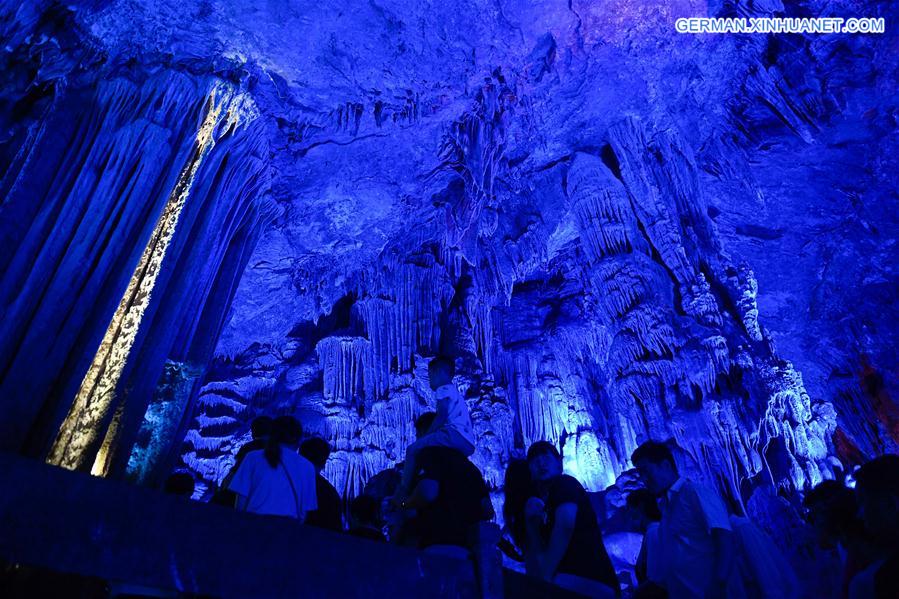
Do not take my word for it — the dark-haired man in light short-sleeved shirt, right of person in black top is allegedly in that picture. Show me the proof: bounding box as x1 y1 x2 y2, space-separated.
631 441 744 599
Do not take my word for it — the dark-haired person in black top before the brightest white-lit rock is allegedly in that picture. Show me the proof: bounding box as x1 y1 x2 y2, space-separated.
524 441 619 597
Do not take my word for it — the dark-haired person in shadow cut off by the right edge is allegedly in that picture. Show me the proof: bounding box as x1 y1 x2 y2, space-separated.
849 454 899 599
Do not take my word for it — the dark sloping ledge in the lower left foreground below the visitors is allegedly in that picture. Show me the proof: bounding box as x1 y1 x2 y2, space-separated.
0 454 572 599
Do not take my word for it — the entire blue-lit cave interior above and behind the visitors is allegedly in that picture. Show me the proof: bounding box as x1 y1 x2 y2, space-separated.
0 0 899 596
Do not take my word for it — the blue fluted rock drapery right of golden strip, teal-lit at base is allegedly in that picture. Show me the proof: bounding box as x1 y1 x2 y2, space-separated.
98 86 277 482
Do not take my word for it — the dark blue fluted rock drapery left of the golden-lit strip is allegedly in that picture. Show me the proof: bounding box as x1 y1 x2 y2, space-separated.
0 75 204 453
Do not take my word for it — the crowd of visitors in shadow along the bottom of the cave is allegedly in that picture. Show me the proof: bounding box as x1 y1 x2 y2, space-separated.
166 358 899 599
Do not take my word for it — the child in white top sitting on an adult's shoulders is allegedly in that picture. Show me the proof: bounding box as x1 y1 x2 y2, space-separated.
398 356 475 501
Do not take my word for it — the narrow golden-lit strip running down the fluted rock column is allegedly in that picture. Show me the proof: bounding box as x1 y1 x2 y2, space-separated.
47 87 247 475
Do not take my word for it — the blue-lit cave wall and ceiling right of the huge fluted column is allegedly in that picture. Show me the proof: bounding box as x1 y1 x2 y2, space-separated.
165 3 897 509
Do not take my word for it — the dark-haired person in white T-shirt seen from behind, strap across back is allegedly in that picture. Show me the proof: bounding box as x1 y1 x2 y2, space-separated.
229 416 318 521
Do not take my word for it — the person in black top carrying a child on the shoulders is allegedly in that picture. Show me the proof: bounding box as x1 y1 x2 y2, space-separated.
401 415 494 549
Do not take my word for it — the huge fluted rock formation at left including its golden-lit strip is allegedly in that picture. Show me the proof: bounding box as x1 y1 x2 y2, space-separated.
0 0 274 473
